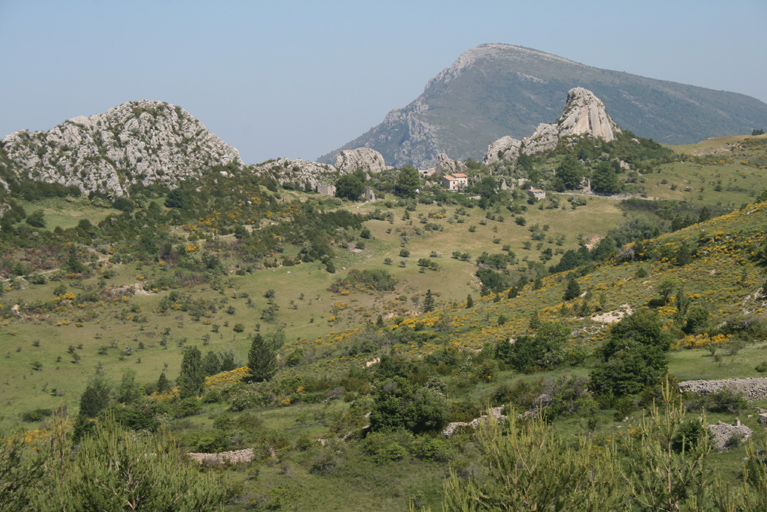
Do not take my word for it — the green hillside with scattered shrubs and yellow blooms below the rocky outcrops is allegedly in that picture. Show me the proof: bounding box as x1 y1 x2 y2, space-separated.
0 132 767 510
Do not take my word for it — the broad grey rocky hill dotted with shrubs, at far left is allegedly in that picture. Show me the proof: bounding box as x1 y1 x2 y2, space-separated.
2 100 242 196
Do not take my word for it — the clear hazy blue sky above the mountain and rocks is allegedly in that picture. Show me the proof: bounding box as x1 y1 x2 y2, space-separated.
0 0 767 163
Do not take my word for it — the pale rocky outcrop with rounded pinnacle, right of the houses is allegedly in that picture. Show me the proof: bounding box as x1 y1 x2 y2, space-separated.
484 87 621 164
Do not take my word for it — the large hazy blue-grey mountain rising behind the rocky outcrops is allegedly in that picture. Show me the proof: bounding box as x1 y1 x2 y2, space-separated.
319 44 767 168
